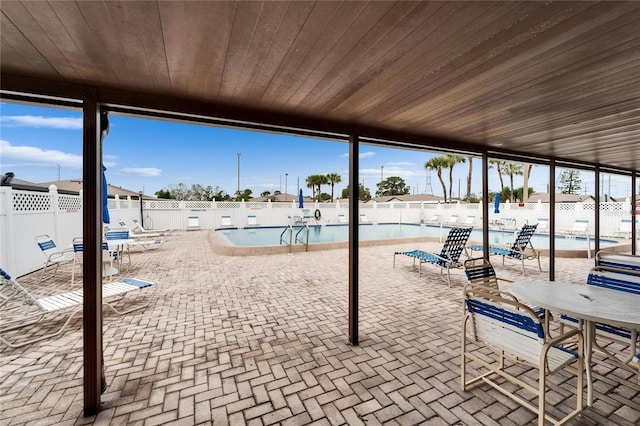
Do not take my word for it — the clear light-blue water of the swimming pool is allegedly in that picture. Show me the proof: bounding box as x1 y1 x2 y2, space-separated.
216 223 617 250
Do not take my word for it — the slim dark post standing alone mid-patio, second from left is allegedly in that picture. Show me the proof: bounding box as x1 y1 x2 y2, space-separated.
349 135 360 345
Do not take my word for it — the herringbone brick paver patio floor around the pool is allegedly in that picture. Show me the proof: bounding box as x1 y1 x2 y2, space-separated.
0 231 640 425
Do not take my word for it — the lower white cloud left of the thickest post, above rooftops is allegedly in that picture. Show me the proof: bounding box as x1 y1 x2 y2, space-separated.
0 140 82 169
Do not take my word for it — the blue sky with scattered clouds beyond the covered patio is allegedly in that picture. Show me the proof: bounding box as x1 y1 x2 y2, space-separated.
0 103 630 197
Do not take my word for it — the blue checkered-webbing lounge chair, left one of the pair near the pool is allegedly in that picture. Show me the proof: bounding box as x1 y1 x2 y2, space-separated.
393 227 473 287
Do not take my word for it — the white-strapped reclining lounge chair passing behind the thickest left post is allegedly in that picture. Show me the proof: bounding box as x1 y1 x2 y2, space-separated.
0 268 158 348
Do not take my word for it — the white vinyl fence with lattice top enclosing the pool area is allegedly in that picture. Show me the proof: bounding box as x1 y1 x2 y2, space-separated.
0 186 631 277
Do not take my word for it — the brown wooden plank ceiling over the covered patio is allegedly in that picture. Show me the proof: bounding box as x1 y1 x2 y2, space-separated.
0 0 640 170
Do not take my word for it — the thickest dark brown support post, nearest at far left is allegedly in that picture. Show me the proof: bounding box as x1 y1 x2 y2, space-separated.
82 88 102 416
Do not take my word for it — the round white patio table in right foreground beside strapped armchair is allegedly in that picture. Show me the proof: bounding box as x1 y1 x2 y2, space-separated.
509 281 640 406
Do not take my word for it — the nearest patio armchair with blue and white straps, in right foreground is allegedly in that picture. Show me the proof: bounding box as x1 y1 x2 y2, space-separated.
460 287 584 426
